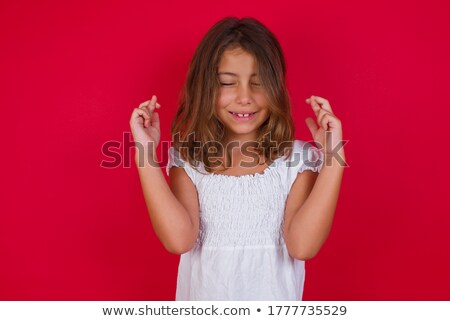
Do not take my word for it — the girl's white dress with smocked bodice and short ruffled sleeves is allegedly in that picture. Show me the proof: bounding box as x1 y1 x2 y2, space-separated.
166 140 323 301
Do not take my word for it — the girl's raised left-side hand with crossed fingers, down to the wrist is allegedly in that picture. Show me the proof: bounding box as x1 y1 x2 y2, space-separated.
130 95 161 154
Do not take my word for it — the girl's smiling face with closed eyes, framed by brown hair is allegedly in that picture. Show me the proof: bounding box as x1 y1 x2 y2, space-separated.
216 48 270 142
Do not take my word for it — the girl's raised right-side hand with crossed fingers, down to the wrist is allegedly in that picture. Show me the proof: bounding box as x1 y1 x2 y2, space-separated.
305 96 342 154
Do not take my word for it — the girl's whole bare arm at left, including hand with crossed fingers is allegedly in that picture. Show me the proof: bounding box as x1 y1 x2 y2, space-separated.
130 95 199 254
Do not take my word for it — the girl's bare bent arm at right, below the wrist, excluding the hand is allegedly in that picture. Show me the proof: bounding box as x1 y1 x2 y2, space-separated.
284 149 345 260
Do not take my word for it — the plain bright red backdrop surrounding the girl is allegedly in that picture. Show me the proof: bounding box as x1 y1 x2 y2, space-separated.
0 0 450 300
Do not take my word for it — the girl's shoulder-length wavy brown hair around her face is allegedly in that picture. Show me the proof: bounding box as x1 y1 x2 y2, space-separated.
171 17 295 173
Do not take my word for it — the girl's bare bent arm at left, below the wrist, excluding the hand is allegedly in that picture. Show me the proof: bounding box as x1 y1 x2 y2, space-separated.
135 153 199 254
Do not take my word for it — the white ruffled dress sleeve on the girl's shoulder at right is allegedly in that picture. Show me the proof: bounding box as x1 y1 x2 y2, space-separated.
286 140 324 189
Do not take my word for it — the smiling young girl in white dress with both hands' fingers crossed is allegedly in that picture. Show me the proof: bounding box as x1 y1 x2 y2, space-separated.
130 17 345 300
